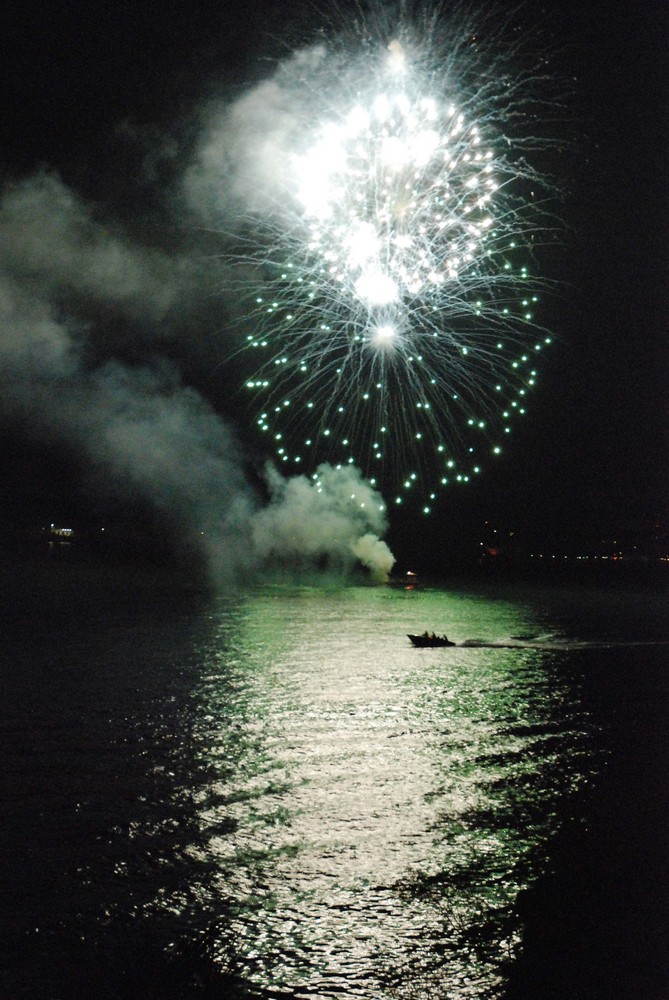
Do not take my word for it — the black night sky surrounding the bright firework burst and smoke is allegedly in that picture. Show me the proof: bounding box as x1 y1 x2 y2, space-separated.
0 0 669 572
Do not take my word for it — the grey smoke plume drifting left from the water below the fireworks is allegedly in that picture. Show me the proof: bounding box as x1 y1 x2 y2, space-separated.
0 157 393 584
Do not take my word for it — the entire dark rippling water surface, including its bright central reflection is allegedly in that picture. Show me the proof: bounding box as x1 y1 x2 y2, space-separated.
0 567 669 1000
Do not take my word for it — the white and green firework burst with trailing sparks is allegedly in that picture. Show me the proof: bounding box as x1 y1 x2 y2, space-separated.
213 3 550 513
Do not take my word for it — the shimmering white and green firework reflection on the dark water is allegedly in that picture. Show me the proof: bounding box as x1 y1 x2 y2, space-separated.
174 588 594 1000
